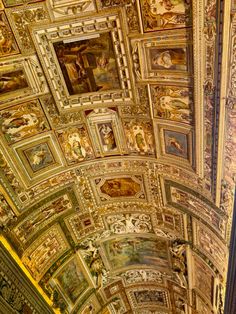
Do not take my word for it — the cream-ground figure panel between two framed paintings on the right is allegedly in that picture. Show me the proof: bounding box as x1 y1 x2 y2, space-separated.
151 85 192 124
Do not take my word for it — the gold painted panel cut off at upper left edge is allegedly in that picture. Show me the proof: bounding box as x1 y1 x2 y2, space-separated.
0 12 19 57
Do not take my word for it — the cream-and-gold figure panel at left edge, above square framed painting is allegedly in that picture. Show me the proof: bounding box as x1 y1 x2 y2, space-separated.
0 101 50 143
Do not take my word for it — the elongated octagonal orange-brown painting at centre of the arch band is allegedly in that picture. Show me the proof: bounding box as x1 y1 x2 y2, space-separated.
100 178 141 197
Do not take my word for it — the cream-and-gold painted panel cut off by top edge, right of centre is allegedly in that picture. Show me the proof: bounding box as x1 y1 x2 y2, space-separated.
141 0 191 32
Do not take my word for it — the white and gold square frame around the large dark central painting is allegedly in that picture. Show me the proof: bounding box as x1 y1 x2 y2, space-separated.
32 15 133 109
